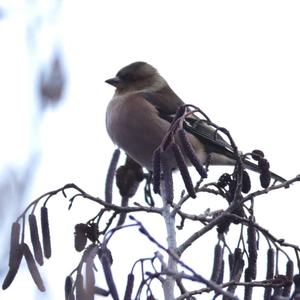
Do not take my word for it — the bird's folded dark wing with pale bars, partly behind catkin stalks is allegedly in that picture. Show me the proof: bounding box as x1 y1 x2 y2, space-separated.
142 88 233 158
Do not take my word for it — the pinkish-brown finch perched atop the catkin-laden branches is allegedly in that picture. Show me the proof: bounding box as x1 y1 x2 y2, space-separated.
105 61 285 182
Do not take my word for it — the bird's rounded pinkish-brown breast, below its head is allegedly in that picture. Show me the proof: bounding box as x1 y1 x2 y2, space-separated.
106 95 169 169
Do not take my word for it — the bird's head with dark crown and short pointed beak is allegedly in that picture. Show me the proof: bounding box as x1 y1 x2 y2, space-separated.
105 61 167 93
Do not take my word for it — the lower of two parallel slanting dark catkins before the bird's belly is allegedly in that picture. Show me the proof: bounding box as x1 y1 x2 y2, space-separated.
171 143 196 198
